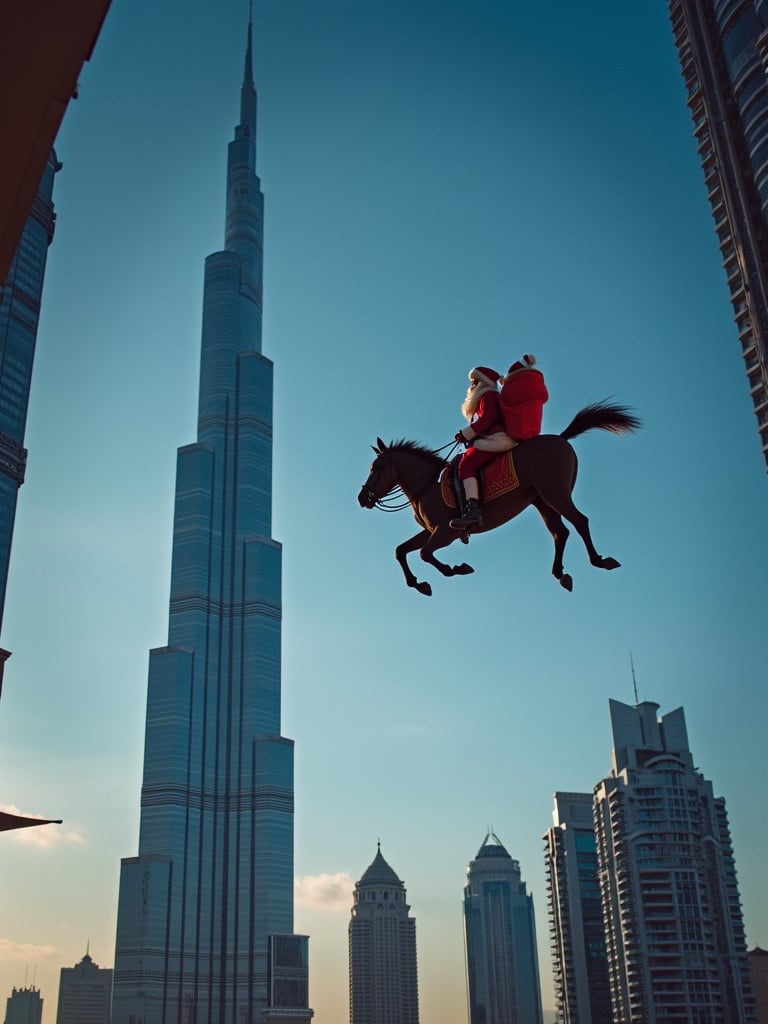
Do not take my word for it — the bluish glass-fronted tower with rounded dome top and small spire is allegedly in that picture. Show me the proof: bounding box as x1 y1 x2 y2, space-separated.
464 831 542 1024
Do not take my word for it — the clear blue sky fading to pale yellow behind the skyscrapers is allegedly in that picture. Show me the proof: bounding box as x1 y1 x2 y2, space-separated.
0 0 768 1024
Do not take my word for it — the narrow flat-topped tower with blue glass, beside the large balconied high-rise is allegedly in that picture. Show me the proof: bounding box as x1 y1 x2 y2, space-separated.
544 793 613 1024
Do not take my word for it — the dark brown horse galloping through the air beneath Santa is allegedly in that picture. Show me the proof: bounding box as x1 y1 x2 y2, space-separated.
357 401 640 596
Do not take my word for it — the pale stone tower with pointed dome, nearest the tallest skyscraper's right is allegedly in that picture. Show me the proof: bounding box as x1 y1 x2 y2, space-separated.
349 845 419 1024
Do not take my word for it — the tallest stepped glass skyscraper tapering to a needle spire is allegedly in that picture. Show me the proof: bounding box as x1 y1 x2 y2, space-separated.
113 14 312 1024
